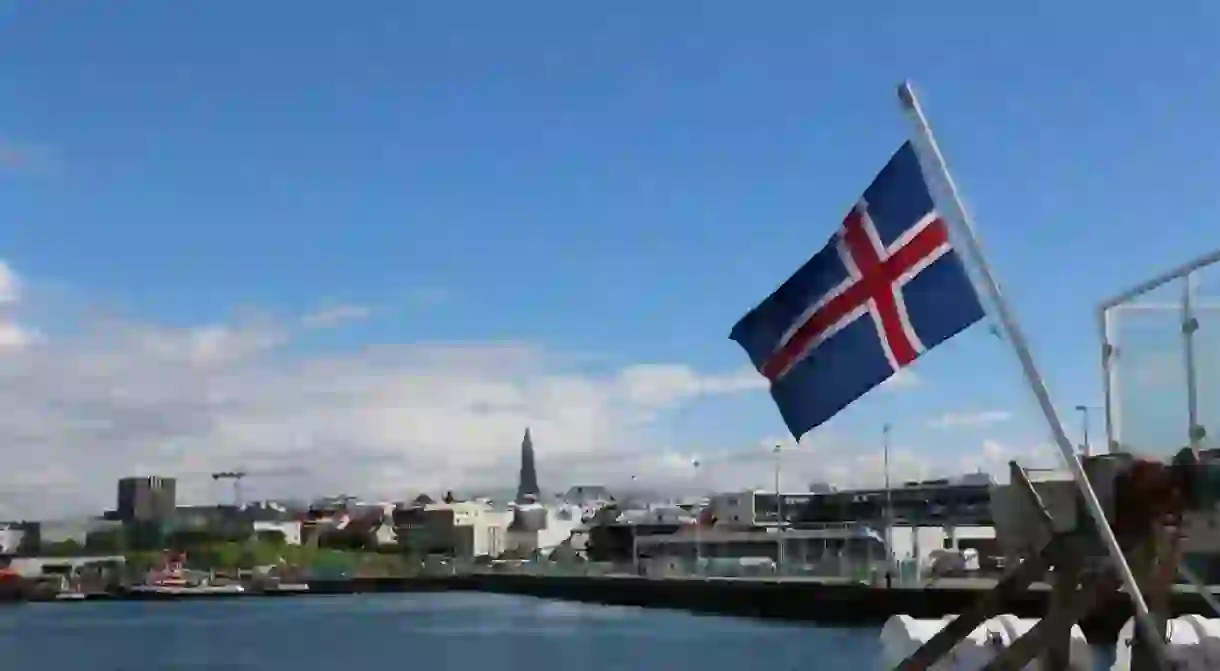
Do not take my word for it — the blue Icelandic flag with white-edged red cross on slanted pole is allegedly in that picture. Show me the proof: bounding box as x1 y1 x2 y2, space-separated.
730 143 985 439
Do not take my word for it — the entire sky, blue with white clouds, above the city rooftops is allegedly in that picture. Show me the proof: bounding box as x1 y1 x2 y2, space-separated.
0 0 1220 517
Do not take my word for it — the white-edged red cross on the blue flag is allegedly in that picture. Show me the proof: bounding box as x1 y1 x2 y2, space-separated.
763 204 949 381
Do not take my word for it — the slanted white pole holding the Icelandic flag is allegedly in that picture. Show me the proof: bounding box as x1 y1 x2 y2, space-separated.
898 82 1166 659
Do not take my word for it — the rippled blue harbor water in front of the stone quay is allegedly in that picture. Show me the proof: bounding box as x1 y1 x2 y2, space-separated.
0 593 878 671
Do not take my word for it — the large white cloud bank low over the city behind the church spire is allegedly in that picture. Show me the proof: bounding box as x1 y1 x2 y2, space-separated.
0 259 759 517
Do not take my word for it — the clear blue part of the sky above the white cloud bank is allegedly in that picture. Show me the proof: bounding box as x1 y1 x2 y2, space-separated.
0 0 1220 509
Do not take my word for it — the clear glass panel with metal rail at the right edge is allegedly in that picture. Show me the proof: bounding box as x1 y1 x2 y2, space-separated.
1086 251 1220 459
